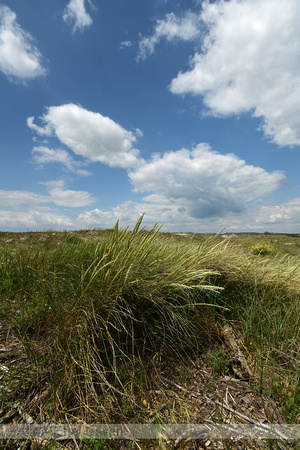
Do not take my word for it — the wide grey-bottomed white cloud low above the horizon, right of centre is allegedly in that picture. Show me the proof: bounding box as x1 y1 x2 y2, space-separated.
129 144 285 219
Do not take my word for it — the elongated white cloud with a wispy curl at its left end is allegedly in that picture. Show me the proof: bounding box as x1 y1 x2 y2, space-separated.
27 103 142 169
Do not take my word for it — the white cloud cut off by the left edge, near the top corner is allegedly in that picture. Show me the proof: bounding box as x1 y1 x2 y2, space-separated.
0 5 46 82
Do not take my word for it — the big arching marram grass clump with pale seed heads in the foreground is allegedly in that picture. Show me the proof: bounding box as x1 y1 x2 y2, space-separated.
0 217 224 422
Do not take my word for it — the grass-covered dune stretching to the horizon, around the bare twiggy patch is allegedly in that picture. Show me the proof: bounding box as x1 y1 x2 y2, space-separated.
0 217 300 448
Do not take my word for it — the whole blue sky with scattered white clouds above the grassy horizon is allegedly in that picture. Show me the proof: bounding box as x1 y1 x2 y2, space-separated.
0 0 300 233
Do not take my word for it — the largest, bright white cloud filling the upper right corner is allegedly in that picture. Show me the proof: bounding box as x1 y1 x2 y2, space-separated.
170 0 300 146
